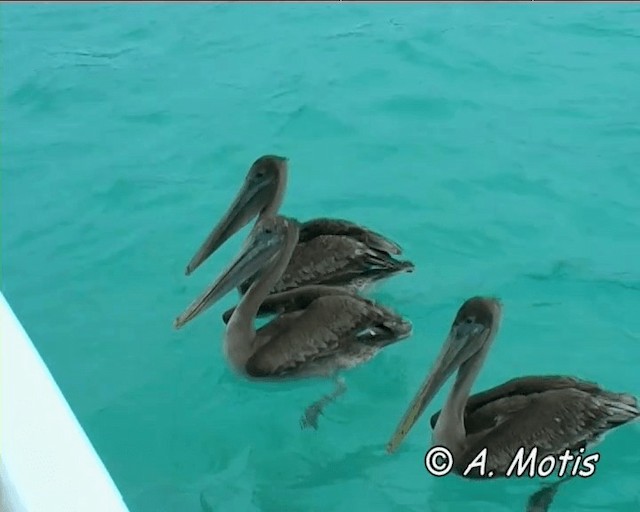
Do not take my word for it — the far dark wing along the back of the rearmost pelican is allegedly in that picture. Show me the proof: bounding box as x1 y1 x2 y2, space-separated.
299 218 402 255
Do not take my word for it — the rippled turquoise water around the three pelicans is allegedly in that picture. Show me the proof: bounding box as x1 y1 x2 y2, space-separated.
1 4 640 512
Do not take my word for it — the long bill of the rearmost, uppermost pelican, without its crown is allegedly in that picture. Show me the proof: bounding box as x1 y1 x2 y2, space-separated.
185 174 274 275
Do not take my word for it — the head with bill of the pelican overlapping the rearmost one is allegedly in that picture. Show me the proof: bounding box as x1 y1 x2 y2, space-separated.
174 216 300 329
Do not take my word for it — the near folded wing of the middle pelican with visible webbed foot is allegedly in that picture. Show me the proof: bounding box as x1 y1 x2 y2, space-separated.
246 294 402 377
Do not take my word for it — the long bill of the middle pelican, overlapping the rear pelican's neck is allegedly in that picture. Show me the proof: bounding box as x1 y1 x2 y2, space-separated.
178 228 281 329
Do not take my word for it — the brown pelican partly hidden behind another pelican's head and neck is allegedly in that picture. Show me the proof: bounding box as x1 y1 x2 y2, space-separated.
185 155 414 294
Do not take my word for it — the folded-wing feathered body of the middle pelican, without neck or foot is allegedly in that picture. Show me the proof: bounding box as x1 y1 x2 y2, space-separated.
245 287 411 378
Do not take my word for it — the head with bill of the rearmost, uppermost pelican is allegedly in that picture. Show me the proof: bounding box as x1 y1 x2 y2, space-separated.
185 155 288 275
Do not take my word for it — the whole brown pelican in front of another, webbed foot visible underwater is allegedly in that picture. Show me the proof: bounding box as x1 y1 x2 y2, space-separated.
174 216 411 428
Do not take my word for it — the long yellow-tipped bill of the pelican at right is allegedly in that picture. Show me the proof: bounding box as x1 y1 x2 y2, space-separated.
387 322 489 453
